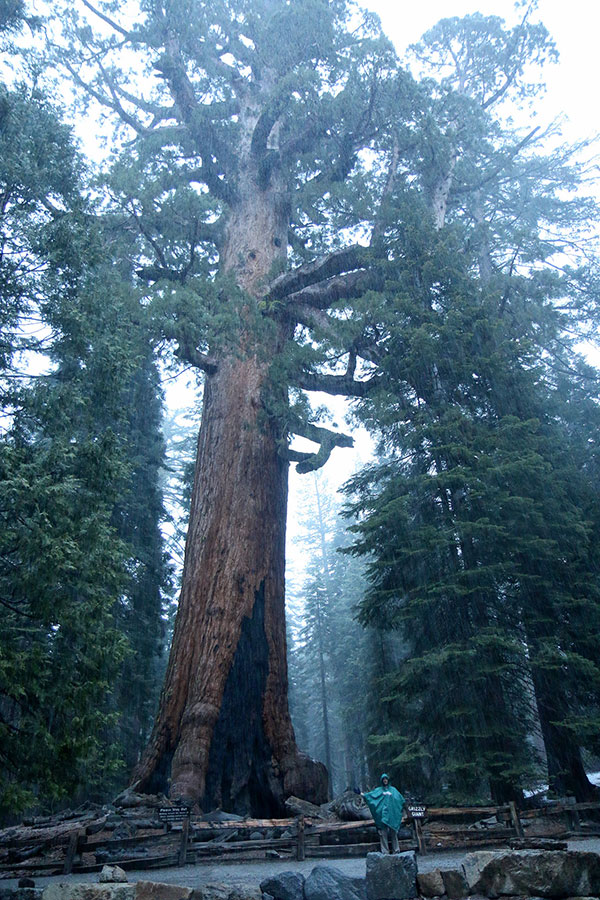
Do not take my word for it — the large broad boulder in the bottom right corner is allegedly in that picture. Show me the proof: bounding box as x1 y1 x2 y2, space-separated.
463 850 600 897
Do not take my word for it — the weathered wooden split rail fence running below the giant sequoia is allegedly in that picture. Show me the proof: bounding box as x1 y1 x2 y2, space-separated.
0 802 600 877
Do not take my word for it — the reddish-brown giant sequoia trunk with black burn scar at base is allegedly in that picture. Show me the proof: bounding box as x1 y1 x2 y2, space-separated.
133 142 327 816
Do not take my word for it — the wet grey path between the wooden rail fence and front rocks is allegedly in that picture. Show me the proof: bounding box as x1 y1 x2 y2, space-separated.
1 838 600 889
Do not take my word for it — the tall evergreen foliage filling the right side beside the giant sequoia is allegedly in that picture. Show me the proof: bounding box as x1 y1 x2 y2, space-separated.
342 16 600 801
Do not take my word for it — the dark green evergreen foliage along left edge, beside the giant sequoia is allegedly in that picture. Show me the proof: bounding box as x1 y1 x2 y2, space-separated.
0 17 167 815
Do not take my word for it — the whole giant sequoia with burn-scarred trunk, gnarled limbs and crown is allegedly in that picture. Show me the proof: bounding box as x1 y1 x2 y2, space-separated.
52 0 410 813
